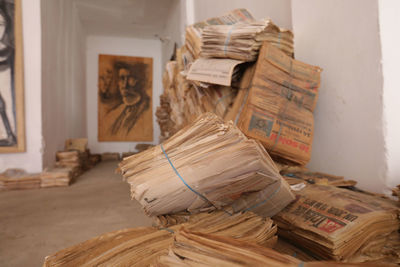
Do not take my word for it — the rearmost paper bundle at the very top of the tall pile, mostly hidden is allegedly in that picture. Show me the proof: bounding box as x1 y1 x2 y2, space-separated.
185 8 254 58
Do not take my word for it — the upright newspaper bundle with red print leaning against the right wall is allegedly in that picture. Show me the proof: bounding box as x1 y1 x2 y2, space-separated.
238 42 321 165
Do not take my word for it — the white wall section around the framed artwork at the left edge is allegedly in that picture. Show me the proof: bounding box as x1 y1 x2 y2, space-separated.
0 0 43 172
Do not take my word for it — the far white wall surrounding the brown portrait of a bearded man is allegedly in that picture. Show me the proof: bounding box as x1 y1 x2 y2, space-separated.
86 36 162 153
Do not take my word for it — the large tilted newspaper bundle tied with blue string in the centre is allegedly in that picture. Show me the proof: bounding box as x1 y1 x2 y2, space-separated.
119 113 293 219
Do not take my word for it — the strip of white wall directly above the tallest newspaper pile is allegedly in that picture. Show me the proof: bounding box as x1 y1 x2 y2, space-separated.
190 0 292 29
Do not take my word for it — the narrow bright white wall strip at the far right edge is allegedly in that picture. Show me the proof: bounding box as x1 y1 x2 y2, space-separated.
379 0 400 191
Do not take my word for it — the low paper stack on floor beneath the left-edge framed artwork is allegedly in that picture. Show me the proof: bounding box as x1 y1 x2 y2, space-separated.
0 169 40 190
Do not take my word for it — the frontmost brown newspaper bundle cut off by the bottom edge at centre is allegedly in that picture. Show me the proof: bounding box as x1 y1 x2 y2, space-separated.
152 228 378 267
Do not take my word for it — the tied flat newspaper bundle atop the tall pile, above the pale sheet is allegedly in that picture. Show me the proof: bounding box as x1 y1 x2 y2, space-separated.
201 19 294 62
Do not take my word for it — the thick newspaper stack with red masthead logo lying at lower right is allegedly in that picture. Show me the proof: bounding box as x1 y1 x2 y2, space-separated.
273 185 400 263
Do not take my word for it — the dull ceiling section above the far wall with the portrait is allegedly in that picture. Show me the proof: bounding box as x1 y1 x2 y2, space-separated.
74 0 174 38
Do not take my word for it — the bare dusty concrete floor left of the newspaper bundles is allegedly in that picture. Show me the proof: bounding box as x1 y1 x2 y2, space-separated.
0 161 152 267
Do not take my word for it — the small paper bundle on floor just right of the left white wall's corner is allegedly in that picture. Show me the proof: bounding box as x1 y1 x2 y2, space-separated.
40 168 73 187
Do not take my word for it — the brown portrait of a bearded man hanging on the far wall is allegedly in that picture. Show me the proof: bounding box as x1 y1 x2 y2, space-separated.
98 55 153 141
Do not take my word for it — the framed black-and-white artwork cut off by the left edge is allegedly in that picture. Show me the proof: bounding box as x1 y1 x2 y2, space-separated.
0 0 25 153
